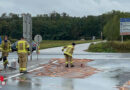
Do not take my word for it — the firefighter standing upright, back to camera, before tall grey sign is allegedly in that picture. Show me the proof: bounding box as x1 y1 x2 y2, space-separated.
16 38 29 73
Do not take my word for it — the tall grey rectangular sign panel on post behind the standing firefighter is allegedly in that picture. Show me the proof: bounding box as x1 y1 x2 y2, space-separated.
23 14 32 61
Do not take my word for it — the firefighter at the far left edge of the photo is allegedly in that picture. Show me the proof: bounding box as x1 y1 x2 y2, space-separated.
0 36 11 69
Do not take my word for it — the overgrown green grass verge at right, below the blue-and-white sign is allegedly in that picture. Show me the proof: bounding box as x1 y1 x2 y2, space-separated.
86 41 130 53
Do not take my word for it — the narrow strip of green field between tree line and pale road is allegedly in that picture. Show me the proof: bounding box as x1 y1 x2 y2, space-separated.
40 40 99 49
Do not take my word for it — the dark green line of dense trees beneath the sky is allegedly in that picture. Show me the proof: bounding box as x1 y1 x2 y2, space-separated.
0 11 130 40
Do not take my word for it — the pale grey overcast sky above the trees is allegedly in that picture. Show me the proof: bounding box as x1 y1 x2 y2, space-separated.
0 0 130 17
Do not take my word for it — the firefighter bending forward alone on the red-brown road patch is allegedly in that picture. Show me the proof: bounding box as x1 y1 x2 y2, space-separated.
62 43 75 67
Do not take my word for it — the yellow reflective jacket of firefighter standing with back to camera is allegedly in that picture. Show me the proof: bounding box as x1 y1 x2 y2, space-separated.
16 40 29 53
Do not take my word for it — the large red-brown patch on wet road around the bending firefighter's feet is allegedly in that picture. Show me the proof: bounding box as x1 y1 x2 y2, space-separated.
30 58 99 78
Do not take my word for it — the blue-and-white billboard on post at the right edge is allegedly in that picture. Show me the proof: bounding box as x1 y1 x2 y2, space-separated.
120 18 130 42
